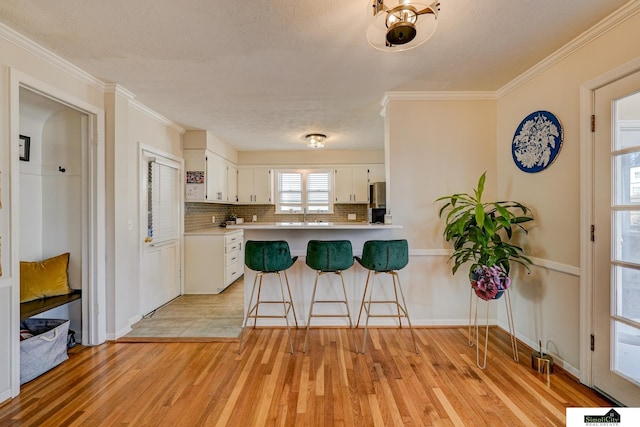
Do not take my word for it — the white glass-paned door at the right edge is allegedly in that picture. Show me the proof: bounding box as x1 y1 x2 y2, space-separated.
592 68 640 407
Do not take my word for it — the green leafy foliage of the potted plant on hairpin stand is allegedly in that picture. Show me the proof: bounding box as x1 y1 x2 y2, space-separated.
436 172 533 277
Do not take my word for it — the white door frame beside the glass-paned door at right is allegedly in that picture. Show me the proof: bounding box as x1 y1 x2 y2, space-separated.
579 58 640 387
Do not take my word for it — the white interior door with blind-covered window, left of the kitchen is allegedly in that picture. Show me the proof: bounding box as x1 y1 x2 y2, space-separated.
140 150 182 315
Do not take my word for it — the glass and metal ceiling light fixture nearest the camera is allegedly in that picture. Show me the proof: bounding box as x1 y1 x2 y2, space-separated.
367 0 440 52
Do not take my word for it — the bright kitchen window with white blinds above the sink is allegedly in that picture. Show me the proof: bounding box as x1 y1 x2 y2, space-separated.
276 169 333 213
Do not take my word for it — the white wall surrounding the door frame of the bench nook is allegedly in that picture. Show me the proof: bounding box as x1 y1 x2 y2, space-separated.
0 26 102 402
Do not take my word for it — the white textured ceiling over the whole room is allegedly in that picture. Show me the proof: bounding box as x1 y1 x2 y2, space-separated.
0 0 637 151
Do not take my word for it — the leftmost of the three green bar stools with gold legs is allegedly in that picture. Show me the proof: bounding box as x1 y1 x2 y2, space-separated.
238 240 298 354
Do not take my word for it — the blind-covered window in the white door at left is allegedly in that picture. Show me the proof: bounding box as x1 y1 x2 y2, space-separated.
147 158 180 244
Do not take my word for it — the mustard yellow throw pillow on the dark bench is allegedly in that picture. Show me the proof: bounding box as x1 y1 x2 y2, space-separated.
20 252 72 302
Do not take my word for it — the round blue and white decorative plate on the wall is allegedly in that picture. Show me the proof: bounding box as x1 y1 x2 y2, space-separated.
511 111 564 173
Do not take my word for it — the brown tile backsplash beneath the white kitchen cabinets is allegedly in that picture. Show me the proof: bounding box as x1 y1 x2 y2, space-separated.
184 202 368 231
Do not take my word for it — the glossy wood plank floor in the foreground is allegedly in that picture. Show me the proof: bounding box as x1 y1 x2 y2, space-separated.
0 328 611 427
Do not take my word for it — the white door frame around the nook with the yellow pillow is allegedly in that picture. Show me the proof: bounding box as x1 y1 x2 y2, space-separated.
9 68 107 397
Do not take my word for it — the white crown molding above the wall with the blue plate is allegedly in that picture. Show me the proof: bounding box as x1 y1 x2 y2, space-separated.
496 0 640 98
